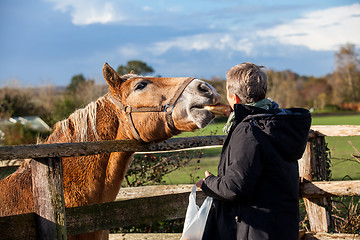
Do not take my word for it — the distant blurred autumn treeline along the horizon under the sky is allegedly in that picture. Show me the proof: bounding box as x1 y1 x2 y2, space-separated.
0 44 360 129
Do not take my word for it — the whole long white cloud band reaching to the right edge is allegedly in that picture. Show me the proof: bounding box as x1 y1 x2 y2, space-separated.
143 3 360 56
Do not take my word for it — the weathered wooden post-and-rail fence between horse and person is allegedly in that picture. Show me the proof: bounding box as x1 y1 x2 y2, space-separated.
0 125 360 239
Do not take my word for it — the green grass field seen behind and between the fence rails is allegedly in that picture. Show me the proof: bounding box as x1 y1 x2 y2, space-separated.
164 114 360 184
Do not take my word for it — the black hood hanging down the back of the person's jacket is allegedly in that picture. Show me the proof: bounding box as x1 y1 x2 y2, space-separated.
234 104 311 161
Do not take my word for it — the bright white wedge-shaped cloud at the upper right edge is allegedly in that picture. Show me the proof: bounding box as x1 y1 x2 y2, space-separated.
257 3 360 51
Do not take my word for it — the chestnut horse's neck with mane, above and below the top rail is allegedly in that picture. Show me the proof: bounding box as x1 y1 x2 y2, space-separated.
47 97 133 203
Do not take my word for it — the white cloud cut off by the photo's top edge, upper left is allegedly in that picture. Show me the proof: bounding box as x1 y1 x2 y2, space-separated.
44 0 198 26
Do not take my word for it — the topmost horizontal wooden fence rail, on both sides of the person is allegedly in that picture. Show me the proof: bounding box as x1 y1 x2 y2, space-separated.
0 125 360 163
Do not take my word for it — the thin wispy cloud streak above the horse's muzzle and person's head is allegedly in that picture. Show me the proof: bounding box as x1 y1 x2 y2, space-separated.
150 33 253 55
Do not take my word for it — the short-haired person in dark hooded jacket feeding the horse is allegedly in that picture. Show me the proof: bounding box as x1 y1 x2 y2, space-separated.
196 62 311 240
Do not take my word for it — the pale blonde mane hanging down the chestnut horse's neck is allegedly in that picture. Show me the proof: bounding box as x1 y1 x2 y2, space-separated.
57 96 105 142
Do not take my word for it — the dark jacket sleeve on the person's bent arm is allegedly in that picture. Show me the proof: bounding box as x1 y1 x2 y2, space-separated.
201 125 264 201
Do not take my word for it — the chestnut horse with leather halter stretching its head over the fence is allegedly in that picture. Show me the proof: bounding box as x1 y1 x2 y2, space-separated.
0 63 220 239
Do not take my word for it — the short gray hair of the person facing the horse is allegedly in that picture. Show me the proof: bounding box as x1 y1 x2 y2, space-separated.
226 62 267 104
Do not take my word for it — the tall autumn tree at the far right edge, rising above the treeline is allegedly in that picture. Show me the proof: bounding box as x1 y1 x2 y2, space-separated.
332 43 360 104
